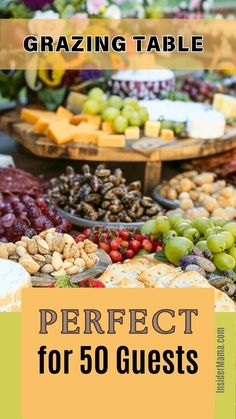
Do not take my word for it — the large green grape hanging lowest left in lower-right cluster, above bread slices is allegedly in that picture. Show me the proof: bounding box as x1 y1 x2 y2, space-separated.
165 237 193 266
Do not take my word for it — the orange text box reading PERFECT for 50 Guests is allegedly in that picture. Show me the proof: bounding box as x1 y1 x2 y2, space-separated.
22 289 214 419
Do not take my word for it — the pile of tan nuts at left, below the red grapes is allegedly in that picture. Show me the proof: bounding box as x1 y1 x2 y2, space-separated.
0 228 97 277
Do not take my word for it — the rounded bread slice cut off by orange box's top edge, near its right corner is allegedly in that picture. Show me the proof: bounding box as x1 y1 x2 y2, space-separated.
170 271 211 288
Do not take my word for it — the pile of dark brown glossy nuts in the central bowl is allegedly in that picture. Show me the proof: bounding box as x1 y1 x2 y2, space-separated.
48 164 161 223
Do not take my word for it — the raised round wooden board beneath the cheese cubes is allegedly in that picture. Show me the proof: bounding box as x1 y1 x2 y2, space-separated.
0 111 236 162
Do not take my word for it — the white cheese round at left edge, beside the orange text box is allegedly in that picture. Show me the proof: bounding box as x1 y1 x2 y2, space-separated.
0 259 31 312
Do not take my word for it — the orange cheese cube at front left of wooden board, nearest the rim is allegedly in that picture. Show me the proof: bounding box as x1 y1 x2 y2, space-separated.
46 119 78 144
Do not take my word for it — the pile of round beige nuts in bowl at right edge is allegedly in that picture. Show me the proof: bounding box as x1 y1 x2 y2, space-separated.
160 170 236 220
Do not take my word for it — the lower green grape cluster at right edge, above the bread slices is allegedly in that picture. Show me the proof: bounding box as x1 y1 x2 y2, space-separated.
142 214 236 272
